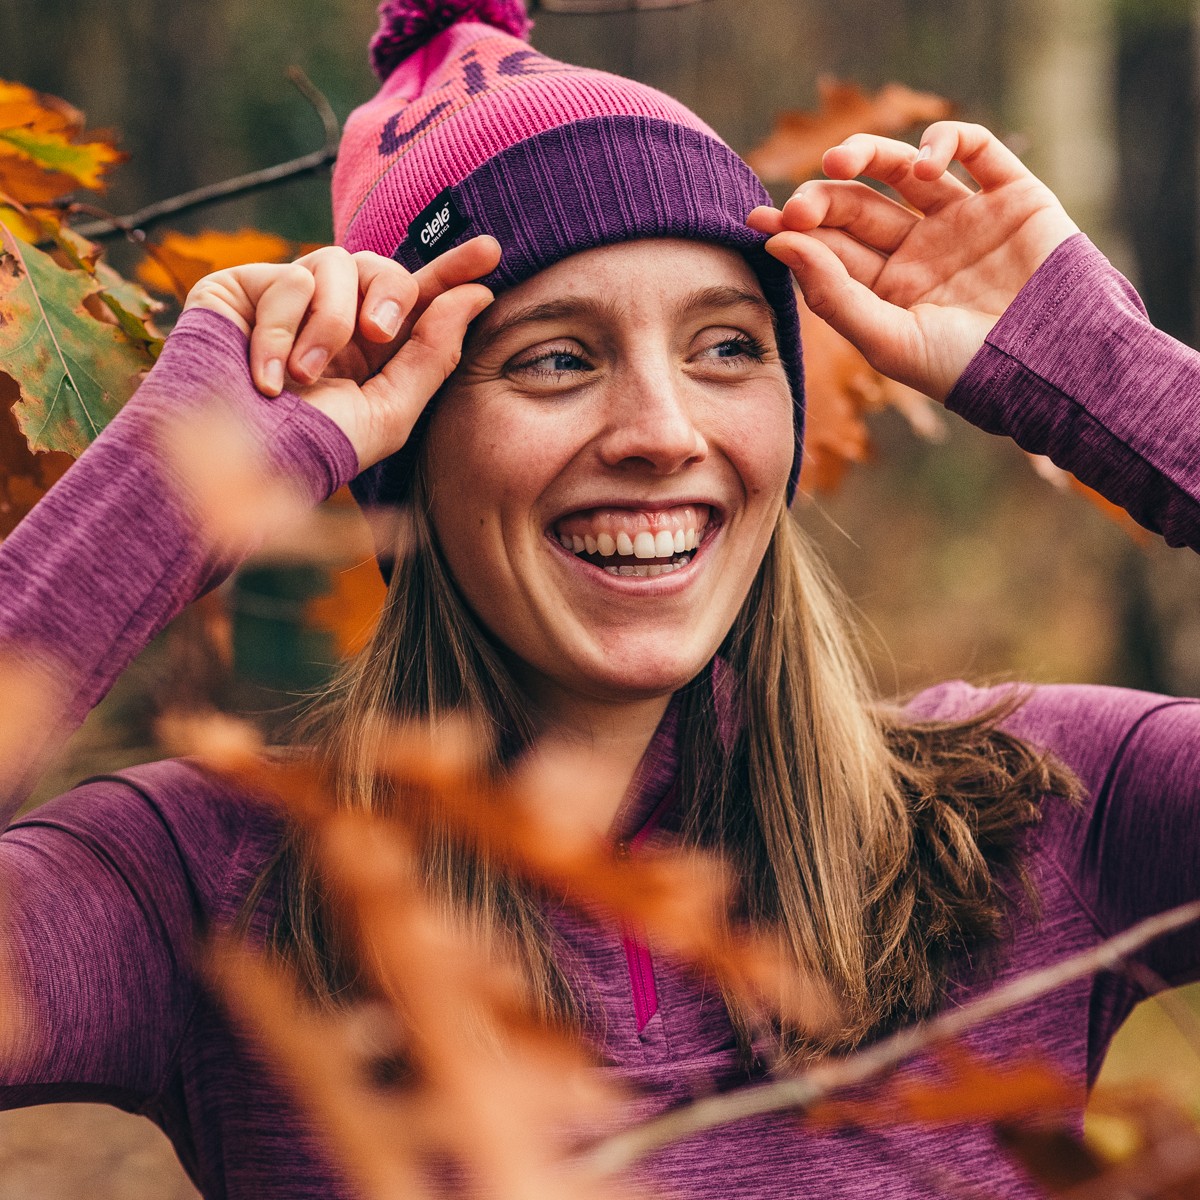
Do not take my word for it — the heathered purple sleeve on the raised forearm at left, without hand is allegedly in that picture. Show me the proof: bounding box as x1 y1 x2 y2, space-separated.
0 308 356 824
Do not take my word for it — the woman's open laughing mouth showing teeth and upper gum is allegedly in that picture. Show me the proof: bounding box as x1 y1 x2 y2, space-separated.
550 505 713 578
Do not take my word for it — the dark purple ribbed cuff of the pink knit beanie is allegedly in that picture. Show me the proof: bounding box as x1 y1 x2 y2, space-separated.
347 116 804 516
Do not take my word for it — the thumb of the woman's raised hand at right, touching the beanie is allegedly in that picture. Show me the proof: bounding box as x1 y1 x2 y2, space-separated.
767 233 912 374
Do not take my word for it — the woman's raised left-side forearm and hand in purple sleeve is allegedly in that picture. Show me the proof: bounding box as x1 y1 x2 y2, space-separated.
0 239 499 823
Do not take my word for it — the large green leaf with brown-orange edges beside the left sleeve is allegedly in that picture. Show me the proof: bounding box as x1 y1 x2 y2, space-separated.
0 226 151 455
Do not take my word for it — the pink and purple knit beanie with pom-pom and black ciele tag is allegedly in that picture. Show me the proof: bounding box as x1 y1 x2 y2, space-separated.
334 0 804 505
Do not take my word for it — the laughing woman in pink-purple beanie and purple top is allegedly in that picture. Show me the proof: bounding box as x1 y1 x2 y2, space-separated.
0 0 1200 1196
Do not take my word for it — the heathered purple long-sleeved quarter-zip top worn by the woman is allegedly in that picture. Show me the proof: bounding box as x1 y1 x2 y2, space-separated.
0 239 1200 1200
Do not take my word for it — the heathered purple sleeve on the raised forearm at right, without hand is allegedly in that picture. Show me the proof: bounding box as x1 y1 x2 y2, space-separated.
946 235 1200 550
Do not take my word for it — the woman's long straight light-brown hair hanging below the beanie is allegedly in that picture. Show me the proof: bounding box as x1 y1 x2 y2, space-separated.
247 466 1076 1062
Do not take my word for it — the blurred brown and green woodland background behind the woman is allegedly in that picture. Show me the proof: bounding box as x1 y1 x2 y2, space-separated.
0 0 1200 1200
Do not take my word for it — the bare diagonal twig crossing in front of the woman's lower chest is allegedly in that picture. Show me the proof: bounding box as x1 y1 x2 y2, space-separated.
580 901 1200 1180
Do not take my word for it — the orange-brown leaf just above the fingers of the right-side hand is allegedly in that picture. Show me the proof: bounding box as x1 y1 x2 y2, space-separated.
746 76 953 184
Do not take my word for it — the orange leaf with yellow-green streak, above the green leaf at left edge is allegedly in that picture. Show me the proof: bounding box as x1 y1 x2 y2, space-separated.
0 80 127 204
